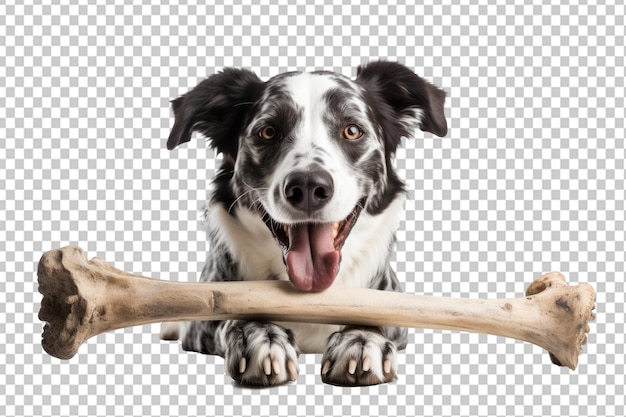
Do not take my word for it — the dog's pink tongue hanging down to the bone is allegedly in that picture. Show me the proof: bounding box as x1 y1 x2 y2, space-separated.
287 223 341 291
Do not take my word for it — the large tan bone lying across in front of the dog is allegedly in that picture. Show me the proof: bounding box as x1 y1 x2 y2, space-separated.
38 246 595 369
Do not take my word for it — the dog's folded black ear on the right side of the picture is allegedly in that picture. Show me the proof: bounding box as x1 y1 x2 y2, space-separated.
356 61 448 136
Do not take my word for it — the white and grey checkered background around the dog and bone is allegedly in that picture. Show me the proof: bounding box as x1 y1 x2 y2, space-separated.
0 0 626 416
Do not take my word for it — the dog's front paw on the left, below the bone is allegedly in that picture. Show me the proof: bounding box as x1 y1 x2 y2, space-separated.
224 322 299 387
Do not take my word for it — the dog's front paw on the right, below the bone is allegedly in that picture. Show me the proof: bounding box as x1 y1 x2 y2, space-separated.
322 328 396 386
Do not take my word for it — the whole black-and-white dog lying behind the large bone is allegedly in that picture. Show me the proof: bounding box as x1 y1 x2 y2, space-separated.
161 61 448 386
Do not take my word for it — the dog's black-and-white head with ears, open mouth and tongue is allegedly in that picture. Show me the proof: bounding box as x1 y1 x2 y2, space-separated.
167 62 447 291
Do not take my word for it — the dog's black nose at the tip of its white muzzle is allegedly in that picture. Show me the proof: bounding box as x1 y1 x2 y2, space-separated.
285 169 334 213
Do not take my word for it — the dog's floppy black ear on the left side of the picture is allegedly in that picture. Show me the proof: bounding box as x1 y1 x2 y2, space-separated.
167 68 265 158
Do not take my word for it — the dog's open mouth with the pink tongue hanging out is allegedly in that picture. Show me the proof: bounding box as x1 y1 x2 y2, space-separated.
266 201 365 291
